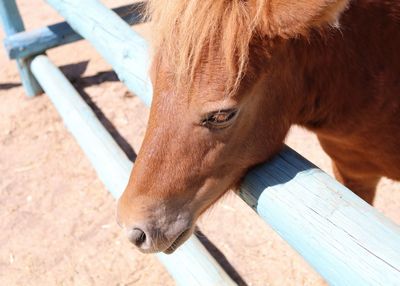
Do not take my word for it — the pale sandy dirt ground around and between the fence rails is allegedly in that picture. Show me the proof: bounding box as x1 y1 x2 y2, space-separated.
0 0 400 286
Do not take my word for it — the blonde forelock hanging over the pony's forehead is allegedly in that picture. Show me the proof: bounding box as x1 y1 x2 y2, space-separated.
147 0 266 95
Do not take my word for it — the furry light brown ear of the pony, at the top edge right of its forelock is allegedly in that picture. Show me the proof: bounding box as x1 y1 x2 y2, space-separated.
264 0 349 37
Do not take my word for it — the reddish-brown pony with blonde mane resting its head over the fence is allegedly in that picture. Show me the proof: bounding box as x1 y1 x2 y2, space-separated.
118 0 400 253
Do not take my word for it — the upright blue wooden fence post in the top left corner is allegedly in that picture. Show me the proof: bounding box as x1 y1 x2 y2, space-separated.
0 0 42 96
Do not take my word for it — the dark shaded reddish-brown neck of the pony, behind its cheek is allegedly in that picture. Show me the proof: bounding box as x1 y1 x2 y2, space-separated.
279 2 400 136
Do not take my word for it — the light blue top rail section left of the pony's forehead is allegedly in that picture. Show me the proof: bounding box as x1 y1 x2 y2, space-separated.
46 0 153 105
